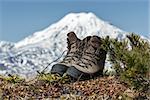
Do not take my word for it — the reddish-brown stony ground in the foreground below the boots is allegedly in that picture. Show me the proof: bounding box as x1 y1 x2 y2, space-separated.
0 76 148 100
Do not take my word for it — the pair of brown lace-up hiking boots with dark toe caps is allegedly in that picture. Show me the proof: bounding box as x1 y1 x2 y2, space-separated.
51 32 106 80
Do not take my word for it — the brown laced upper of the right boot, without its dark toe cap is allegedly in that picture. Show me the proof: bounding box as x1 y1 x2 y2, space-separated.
73 36 106 73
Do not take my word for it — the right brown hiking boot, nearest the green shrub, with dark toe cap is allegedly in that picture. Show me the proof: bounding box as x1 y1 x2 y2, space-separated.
66 36 106 79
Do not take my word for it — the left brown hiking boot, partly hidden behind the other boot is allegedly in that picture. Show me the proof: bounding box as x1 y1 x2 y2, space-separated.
51 32 81 75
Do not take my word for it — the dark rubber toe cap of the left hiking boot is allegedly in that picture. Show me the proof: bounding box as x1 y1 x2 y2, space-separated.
51 64 69 76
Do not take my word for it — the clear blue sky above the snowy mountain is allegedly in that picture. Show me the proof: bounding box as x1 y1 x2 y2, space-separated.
0 0 150 42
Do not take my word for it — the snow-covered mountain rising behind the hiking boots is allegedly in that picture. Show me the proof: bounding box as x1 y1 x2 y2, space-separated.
0 13 127 77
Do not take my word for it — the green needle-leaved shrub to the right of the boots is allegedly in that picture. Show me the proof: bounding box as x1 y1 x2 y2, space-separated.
104 33 150 92
